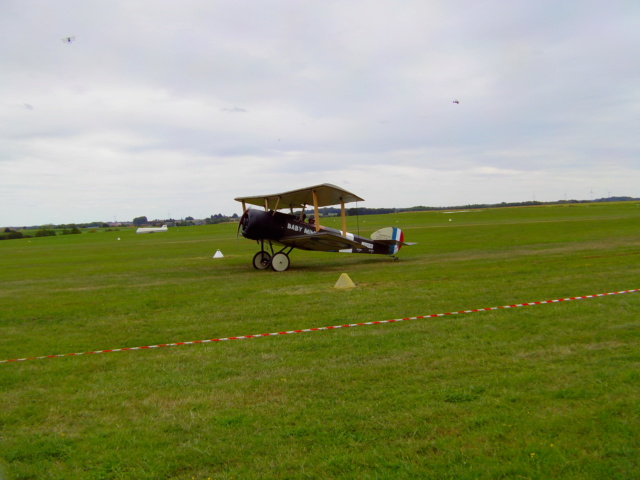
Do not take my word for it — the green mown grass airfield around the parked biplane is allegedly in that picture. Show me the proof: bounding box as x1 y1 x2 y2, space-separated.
0 202 640 479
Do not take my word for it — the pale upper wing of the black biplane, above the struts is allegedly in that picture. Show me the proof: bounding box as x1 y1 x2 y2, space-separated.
235 183 364 210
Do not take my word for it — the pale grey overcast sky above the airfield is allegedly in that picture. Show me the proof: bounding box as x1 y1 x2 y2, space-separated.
0 0 640 226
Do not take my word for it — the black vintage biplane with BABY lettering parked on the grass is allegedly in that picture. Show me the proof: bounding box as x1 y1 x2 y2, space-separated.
235 183 414 272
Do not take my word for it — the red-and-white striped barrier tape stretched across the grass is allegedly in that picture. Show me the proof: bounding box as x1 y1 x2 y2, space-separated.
0 288 640 363
